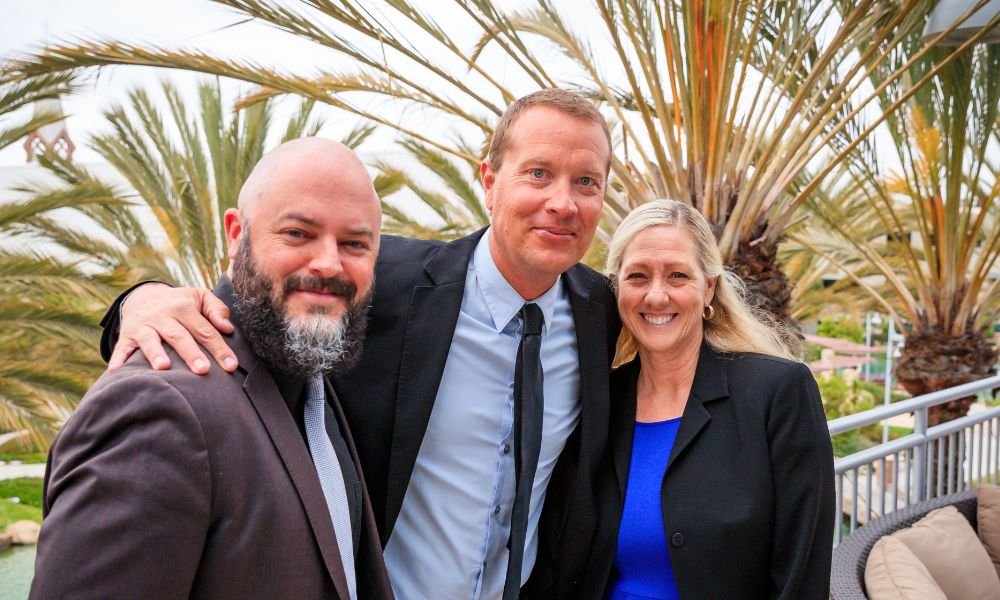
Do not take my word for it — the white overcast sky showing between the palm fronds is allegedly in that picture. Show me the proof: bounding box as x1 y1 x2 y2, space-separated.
0 0 996 180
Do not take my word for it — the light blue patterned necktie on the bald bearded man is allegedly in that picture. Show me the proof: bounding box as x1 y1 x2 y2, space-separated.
305 373 358 600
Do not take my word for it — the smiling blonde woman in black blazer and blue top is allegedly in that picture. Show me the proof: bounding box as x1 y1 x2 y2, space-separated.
583 200 834 600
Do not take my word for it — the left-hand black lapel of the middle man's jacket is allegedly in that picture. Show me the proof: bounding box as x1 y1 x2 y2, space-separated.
382 230 485 544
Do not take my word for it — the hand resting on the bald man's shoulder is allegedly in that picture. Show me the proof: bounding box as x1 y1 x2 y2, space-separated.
108 283 237 375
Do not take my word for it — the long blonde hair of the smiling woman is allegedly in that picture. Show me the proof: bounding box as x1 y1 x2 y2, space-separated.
605 200 797 366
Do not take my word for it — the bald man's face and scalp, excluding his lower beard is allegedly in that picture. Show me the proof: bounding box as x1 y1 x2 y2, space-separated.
225 138 381 328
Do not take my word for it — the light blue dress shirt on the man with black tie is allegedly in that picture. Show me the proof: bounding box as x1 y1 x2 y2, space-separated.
385 231 580 600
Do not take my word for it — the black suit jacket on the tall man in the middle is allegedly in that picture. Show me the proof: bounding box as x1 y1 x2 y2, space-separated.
334 231 620 591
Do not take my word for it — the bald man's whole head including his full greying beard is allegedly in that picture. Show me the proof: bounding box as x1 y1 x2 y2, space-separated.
224 138 382 375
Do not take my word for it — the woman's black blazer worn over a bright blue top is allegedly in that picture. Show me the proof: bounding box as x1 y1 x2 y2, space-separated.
581 345 835 600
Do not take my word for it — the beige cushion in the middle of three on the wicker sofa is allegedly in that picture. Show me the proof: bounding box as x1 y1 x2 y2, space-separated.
891 506 1000 600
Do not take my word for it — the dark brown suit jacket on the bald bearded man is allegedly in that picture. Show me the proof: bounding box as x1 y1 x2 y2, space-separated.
31 280 392 600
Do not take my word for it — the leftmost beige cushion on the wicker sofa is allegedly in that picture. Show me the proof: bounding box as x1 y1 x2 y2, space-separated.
865 536 948 600
